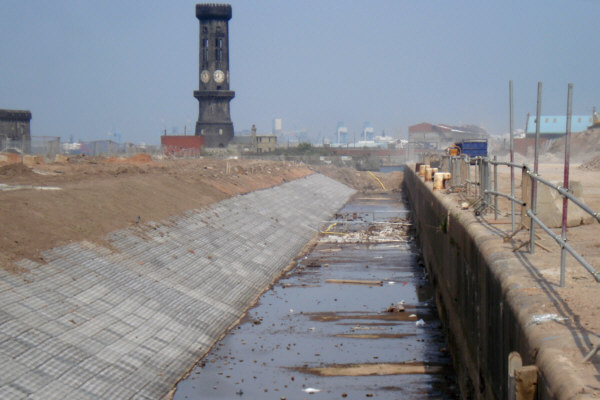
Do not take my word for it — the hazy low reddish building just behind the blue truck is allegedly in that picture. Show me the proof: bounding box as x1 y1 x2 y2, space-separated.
408 122 489 150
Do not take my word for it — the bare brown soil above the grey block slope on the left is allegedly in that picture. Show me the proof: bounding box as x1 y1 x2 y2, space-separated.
0 154 402 272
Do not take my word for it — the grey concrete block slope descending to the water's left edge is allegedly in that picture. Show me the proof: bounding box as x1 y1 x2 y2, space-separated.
0 174 354 399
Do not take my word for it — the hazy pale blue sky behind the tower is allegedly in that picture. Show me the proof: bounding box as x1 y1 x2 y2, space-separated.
0 0 600 143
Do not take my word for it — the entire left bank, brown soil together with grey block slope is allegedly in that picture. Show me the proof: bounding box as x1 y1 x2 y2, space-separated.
0 155 402 399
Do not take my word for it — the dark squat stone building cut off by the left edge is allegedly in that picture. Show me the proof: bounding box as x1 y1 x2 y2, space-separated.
0 110 31 153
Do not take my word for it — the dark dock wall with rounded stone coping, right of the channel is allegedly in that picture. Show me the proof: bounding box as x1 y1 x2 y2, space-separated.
403 166 598 400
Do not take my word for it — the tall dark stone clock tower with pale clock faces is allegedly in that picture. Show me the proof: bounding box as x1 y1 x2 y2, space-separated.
194 4 235 147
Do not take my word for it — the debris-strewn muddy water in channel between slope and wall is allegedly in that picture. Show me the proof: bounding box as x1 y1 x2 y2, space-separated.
174 194 458 399
